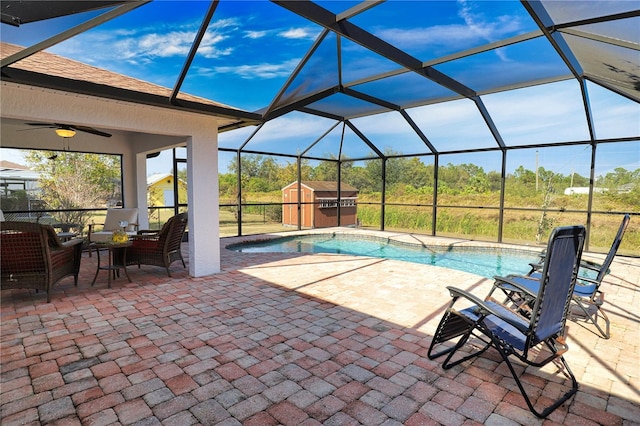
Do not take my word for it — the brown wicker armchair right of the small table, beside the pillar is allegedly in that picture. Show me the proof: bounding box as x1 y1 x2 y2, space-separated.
127 213 187 276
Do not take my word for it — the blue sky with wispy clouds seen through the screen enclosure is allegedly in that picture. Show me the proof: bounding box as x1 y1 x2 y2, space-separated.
1 0 640 173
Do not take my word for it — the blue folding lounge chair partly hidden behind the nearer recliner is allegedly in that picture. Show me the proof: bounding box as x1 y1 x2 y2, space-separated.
492 213 631 339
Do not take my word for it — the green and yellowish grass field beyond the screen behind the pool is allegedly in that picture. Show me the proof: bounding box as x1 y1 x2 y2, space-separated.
220 194 640 256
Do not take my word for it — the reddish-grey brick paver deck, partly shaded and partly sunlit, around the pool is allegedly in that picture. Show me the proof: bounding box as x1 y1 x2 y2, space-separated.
0 228 640 426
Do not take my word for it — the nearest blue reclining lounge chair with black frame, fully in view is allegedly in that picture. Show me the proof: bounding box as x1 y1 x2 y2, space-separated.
427 226 585 418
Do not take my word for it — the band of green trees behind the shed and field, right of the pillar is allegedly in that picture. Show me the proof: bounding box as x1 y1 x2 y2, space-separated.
219 154 640 200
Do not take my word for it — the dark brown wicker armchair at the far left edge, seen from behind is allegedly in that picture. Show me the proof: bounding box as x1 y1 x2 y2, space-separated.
0 222 82 303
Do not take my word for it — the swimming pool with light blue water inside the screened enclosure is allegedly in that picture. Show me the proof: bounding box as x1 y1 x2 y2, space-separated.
227 234 538 278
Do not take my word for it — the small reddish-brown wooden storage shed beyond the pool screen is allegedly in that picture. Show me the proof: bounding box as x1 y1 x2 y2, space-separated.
282 181 358 228
